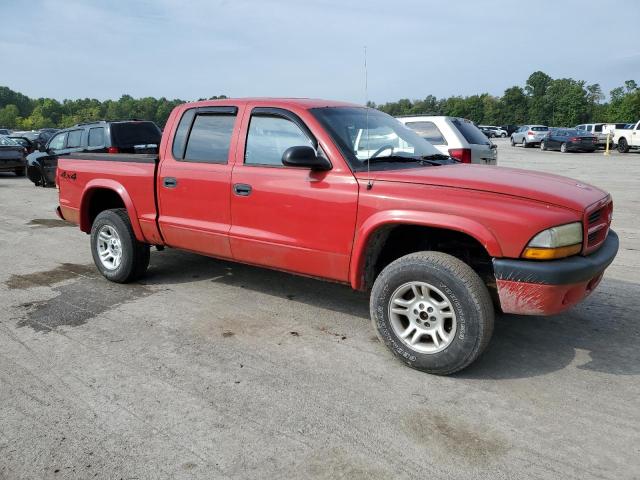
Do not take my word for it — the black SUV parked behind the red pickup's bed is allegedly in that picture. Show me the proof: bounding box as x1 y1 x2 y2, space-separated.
27 120 162 187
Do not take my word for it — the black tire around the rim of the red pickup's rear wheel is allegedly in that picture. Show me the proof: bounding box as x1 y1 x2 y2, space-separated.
91 208 150 283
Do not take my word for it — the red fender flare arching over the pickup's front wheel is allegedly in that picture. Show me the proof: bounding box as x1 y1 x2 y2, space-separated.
349 210 502 290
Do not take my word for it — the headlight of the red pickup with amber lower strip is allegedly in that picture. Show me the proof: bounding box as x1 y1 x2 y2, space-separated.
522 222 582 260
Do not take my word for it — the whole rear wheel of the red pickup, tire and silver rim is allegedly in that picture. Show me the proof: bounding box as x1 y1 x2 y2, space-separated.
91 208 149 283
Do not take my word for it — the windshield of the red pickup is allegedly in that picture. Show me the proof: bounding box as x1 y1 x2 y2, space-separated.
310 107 446 171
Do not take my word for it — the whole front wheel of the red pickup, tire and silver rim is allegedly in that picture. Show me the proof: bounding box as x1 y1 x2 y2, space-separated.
370 252 494 375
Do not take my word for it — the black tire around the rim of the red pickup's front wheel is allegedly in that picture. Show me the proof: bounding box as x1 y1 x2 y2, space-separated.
370 252 494 375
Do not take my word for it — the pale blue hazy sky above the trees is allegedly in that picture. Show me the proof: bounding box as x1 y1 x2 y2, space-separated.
0 0 640 103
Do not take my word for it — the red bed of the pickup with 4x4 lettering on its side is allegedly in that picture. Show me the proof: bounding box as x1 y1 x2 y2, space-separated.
56 152 162 244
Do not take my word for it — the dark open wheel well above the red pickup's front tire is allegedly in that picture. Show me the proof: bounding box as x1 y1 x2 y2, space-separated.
364 225 495 290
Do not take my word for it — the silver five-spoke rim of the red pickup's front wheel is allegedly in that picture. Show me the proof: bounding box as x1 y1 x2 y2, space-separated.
389 282 457 354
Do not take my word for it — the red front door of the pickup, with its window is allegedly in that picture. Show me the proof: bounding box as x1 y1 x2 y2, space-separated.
230 107 358 282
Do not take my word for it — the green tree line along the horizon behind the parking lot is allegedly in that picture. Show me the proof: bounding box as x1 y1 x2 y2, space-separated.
0 71 640 130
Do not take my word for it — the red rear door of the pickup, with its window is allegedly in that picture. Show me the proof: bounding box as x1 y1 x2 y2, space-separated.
156 105 239 258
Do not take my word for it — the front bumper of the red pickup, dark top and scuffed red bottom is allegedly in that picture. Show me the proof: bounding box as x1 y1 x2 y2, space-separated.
493 230 619 315
